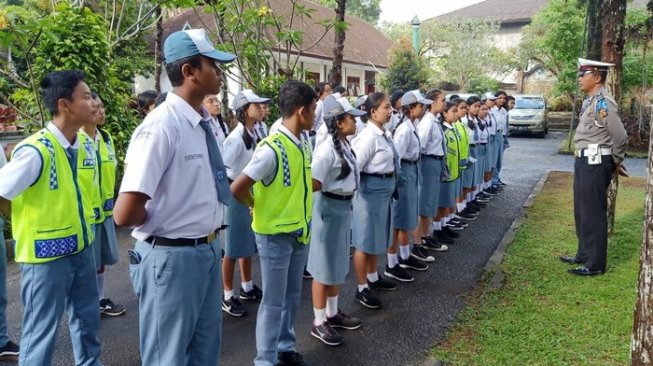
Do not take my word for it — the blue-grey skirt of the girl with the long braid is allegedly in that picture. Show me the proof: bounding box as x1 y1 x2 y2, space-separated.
306 193 352 285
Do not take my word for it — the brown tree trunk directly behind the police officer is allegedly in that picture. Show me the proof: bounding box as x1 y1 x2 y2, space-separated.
601 0 626 235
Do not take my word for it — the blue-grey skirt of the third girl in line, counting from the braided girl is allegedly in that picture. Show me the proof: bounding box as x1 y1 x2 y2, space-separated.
392 162 424 230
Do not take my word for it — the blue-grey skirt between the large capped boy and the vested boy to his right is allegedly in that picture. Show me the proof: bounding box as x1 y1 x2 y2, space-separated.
224 197 256 259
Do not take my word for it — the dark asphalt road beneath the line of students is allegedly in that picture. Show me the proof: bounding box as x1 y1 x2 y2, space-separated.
0 133 645 366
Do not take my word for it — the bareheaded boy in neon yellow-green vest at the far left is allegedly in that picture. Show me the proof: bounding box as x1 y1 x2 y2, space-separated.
0 70 100 366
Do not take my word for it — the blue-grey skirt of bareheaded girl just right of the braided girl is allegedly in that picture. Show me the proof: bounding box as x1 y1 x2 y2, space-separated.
352 174 395 254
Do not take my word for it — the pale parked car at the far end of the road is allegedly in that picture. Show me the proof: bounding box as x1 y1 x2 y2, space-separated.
508 94 549 137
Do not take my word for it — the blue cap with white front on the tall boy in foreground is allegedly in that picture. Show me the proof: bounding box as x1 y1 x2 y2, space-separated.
163 29 236 64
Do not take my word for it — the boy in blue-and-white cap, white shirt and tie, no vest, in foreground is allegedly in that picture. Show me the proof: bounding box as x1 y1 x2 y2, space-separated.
114 29 235 365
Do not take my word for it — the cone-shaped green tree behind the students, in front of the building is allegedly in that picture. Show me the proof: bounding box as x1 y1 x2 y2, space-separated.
381 40 429 92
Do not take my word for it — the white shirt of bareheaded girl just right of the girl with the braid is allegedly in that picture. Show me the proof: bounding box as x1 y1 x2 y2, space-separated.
352 121 395 174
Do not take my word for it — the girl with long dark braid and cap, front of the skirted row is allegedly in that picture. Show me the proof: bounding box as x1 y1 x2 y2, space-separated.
307 95 365 346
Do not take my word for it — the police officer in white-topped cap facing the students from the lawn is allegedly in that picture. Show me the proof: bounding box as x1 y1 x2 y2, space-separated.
560 59 628 276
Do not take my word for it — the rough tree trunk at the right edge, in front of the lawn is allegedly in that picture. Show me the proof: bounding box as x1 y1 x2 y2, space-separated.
630 108 653 366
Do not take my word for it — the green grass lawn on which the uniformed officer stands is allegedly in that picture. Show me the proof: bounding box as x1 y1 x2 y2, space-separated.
430 172 645 366
